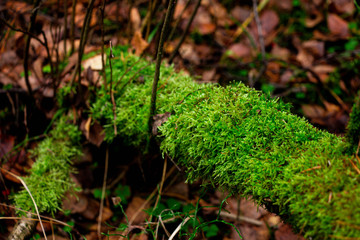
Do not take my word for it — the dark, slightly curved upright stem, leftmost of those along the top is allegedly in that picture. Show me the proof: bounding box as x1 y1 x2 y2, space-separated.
24 0 41 97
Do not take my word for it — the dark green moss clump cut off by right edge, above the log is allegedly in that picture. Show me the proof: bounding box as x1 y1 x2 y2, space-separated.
346 92 360 153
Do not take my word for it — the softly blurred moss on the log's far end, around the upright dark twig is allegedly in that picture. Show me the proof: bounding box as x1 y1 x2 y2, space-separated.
91 47 197 146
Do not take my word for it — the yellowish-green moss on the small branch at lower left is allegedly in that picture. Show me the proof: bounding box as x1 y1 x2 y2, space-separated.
15 118 81 214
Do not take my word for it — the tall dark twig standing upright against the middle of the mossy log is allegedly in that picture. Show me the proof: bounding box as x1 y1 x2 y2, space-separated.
148 0 176 133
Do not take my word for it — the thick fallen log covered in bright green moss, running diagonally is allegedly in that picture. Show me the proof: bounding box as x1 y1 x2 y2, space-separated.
91 46 360 239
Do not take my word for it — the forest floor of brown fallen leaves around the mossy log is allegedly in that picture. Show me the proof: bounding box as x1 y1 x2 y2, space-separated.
0 0 360 240
